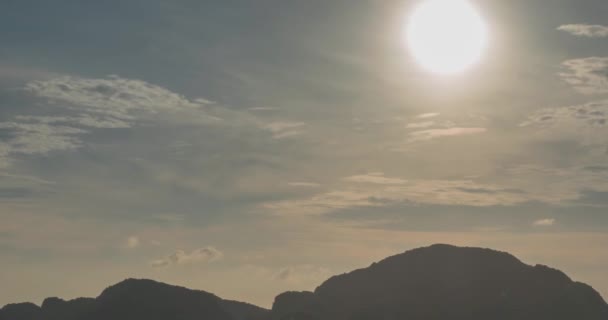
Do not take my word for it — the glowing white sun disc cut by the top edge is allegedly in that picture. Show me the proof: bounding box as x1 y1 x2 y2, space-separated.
407 0 488 74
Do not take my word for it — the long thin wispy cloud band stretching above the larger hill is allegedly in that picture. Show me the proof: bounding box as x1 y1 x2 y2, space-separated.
263 173 536 215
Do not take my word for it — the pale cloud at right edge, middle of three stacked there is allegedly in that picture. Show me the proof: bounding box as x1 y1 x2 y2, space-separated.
559 57 608 94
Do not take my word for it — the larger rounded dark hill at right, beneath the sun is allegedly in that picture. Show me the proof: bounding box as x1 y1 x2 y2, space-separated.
273 245 608 320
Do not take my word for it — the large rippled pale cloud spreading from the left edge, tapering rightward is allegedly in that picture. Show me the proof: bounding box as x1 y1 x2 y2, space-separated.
0 76 262 167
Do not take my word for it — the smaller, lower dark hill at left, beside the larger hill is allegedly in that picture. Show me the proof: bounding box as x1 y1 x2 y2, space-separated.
0 279 268 320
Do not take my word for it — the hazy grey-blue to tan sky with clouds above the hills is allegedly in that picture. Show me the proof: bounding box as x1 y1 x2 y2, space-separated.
0 0 608 307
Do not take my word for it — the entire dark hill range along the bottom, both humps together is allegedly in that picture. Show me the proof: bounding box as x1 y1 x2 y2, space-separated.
0 245 608 320
